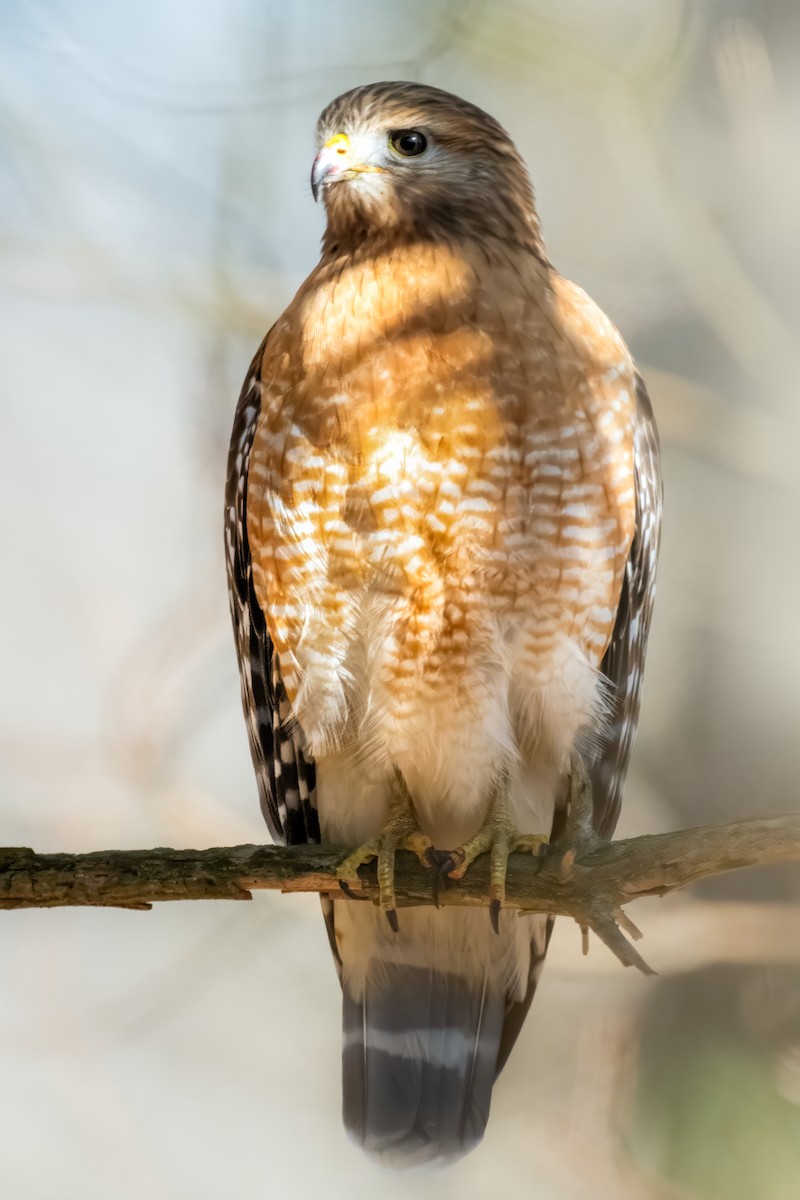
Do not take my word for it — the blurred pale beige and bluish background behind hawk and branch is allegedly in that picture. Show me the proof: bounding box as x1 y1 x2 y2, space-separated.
0 0 800 1200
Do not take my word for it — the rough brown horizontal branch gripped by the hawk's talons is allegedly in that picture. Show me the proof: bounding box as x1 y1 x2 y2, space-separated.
0 812 800 971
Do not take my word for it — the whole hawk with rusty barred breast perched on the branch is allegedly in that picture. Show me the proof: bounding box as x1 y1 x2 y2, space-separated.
225 83 661 1166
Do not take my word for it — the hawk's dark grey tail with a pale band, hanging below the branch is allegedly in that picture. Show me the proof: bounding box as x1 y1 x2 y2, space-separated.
333 904 547 1168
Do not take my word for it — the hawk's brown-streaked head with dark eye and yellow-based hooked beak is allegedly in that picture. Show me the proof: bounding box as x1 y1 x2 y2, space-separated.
311 83 542 253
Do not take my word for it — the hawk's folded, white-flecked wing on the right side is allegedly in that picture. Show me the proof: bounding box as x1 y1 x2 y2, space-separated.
589 374 662 838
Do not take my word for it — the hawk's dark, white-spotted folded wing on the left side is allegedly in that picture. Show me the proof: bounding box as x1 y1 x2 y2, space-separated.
225 331 319 845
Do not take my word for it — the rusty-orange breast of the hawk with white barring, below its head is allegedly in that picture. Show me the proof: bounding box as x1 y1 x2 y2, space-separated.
247 246 633 728
